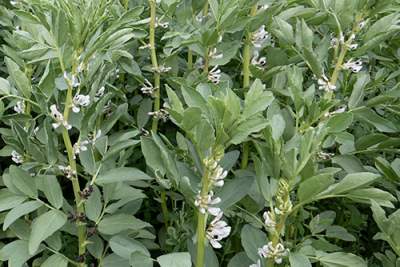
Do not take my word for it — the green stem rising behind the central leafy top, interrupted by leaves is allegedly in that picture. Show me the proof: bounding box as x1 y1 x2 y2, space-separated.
241 5 257 169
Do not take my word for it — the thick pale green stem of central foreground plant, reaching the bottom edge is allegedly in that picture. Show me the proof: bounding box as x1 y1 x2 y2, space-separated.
196 169 209 267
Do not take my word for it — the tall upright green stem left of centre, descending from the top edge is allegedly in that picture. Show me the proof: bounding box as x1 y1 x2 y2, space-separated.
149 0 160 132
